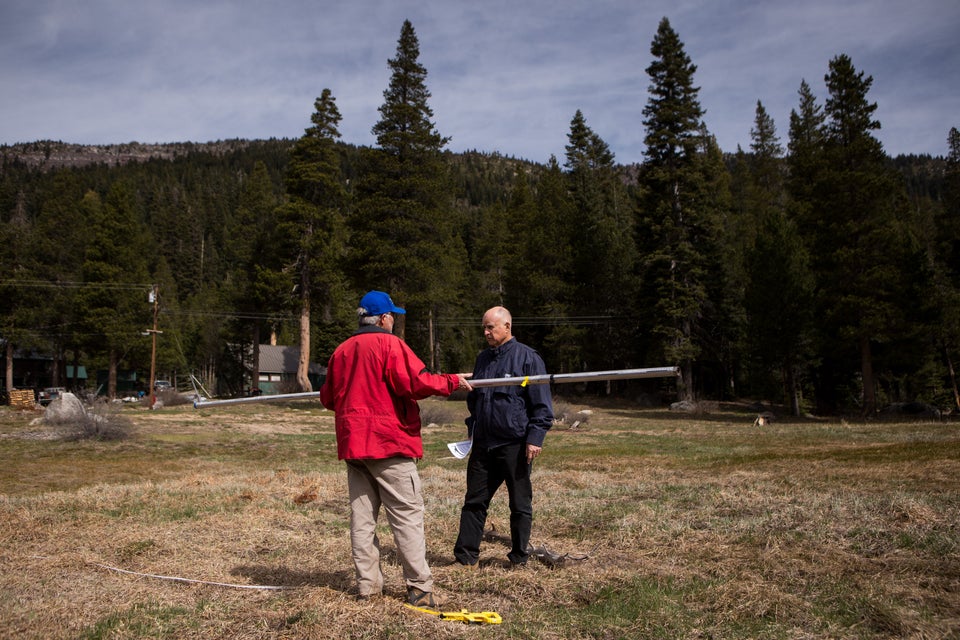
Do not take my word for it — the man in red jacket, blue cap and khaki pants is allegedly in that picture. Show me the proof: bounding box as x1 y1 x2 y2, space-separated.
320 291 471 607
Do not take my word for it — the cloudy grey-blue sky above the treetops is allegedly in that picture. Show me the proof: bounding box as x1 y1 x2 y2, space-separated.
0 0 960 163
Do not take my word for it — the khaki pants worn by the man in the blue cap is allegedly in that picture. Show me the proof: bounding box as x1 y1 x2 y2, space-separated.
347 457 433 595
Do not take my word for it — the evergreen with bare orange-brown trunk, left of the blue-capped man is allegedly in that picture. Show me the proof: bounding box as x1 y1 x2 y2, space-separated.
277 89 346 391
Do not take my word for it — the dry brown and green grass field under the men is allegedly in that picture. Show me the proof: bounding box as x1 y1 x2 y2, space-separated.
0 399 960 640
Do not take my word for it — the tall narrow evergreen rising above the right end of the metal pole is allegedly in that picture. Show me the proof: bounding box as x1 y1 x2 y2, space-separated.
638 18 712 400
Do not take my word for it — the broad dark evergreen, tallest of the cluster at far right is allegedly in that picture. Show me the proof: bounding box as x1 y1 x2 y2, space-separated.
811 55 920 415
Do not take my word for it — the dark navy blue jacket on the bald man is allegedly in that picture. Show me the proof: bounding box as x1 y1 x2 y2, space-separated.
466 338 553 449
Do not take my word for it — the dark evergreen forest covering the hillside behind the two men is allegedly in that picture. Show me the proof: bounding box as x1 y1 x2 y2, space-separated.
0 20 960 415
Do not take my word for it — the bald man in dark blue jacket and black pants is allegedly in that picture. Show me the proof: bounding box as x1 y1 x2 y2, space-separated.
453 307 553 567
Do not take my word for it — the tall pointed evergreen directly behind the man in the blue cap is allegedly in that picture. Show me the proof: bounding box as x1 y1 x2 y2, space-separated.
351 20 472 368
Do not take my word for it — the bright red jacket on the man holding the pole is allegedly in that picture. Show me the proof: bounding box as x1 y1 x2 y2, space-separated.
320 326 459 460
